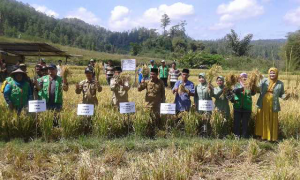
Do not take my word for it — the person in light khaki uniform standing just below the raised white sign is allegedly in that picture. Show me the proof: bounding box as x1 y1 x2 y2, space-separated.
110 67 130 107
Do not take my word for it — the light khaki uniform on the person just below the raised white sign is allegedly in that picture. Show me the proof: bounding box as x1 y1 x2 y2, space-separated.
110 77 130 107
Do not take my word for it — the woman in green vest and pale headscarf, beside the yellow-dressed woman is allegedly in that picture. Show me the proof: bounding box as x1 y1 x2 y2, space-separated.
233 73 255 138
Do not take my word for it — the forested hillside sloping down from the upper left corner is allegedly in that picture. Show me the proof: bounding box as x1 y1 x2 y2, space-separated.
0 0 157 53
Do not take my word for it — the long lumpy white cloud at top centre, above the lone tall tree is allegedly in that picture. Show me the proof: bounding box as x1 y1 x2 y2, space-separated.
109 2 195 31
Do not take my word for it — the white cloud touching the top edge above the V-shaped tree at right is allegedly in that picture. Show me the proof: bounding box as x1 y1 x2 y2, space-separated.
210 0 264 30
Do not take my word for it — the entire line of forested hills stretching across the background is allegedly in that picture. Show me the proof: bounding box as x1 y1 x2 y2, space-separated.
0 0 286 60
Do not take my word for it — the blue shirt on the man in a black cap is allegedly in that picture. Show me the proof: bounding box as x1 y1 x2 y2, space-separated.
173 80 195 111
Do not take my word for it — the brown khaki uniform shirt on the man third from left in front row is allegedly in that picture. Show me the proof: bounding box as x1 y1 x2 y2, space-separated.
75 80 102 105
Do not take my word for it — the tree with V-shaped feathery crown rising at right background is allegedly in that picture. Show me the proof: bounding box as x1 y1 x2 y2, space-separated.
225 29 253 56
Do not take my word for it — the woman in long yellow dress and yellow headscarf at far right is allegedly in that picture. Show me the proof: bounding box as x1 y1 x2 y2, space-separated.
255 68 286 141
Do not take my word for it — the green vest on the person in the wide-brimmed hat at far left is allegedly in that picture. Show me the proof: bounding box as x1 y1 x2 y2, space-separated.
9 81 30 109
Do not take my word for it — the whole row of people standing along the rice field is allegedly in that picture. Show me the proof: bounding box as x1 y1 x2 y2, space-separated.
0 59 287 141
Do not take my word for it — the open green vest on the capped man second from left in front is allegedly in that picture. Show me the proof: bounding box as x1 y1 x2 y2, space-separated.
39 75 63 104
